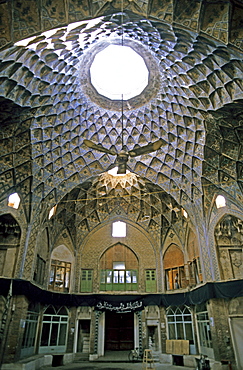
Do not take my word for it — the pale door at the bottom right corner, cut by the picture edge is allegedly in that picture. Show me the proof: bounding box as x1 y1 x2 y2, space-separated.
230 317 243 370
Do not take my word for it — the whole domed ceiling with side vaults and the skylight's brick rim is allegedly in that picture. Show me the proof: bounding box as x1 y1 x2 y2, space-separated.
0 2 243 237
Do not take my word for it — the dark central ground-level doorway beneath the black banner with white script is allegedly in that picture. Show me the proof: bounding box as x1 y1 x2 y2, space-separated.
105 312 134 351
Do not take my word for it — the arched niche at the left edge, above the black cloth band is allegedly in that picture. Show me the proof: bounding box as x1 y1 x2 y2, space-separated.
0 214 21 277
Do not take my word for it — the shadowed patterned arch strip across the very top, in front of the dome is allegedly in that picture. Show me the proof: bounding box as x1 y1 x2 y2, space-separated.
0 0 243 50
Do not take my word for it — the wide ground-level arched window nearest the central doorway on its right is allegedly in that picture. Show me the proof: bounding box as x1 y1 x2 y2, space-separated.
166 306 194 352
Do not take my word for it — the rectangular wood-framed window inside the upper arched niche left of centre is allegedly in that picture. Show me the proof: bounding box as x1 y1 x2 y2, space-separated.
49 260 71 292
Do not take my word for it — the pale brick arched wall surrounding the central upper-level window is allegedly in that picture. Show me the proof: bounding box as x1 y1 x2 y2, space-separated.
78 219 156 293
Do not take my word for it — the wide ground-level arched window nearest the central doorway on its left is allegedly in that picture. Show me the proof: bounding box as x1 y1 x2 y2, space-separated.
39 306 68 353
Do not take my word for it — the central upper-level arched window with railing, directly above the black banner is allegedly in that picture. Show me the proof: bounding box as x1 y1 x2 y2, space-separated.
100 243 138 291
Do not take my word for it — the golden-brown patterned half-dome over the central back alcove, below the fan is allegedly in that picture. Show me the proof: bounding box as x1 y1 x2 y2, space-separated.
51 173 186 245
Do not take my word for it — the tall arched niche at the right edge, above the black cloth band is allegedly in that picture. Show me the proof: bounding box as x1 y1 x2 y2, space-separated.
214 214 243 280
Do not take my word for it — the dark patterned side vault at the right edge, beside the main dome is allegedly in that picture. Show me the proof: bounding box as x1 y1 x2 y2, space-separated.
202 108 243 208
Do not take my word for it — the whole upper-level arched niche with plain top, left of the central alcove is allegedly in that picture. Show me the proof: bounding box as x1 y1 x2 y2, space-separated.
49 244 74 292
